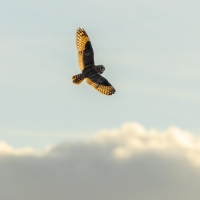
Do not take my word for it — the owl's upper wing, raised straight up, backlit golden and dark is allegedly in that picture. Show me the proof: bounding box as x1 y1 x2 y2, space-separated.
76 28 94 71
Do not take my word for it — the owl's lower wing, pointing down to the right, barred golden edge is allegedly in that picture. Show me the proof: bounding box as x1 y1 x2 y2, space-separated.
86 74 116 95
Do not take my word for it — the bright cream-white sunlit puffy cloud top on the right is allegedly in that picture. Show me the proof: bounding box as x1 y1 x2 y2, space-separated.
95 123 200 165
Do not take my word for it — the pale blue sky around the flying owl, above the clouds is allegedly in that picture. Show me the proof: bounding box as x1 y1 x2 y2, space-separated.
0 0 200 148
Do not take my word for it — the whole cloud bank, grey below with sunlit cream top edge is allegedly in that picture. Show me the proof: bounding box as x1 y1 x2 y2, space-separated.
0 123 200 200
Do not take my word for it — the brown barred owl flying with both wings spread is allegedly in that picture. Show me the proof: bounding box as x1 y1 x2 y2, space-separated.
72 28 116 95
